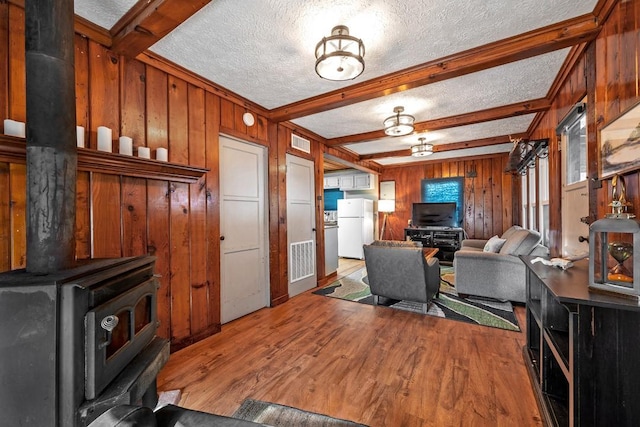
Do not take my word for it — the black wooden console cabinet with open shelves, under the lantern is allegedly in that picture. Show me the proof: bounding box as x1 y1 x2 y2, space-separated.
521 256 640 426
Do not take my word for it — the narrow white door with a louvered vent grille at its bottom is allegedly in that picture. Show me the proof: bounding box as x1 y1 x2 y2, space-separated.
287 154 317 297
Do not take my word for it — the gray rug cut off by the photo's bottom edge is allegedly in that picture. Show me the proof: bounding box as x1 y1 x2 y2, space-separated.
232 399 367 427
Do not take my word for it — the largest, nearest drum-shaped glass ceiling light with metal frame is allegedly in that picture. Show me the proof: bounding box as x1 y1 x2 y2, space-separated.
316 25 364 81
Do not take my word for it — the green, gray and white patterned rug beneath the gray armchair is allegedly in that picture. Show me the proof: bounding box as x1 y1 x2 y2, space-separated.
313 266 520 331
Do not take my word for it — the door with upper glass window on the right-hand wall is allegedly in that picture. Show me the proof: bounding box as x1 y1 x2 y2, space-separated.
561 111 589 258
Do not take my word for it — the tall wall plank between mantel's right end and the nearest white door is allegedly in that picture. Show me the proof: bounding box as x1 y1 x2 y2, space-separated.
205 93 225 333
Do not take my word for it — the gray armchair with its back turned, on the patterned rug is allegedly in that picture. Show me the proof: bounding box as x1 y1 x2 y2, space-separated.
364 241 440 313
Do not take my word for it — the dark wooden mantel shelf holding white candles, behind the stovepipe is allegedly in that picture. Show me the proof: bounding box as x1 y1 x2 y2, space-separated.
0 135 209 183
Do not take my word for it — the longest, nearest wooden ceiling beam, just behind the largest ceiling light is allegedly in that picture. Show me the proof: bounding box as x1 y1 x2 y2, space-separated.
269 14 600 122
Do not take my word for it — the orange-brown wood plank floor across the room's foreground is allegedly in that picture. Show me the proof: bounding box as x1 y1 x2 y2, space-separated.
158 260 541 427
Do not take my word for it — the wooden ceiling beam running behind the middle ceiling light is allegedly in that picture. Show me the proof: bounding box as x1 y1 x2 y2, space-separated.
326 98 551 146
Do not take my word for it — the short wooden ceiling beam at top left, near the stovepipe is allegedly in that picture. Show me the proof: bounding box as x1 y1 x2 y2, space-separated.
110 0 211 58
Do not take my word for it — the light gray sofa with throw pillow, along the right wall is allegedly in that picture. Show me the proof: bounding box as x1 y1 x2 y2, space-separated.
453 225 549 303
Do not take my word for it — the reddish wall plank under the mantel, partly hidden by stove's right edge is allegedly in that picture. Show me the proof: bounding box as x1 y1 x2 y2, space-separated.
146 179 171 339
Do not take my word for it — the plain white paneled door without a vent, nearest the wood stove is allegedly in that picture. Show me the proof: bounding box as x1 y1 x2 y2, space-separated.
220 136 269 323
